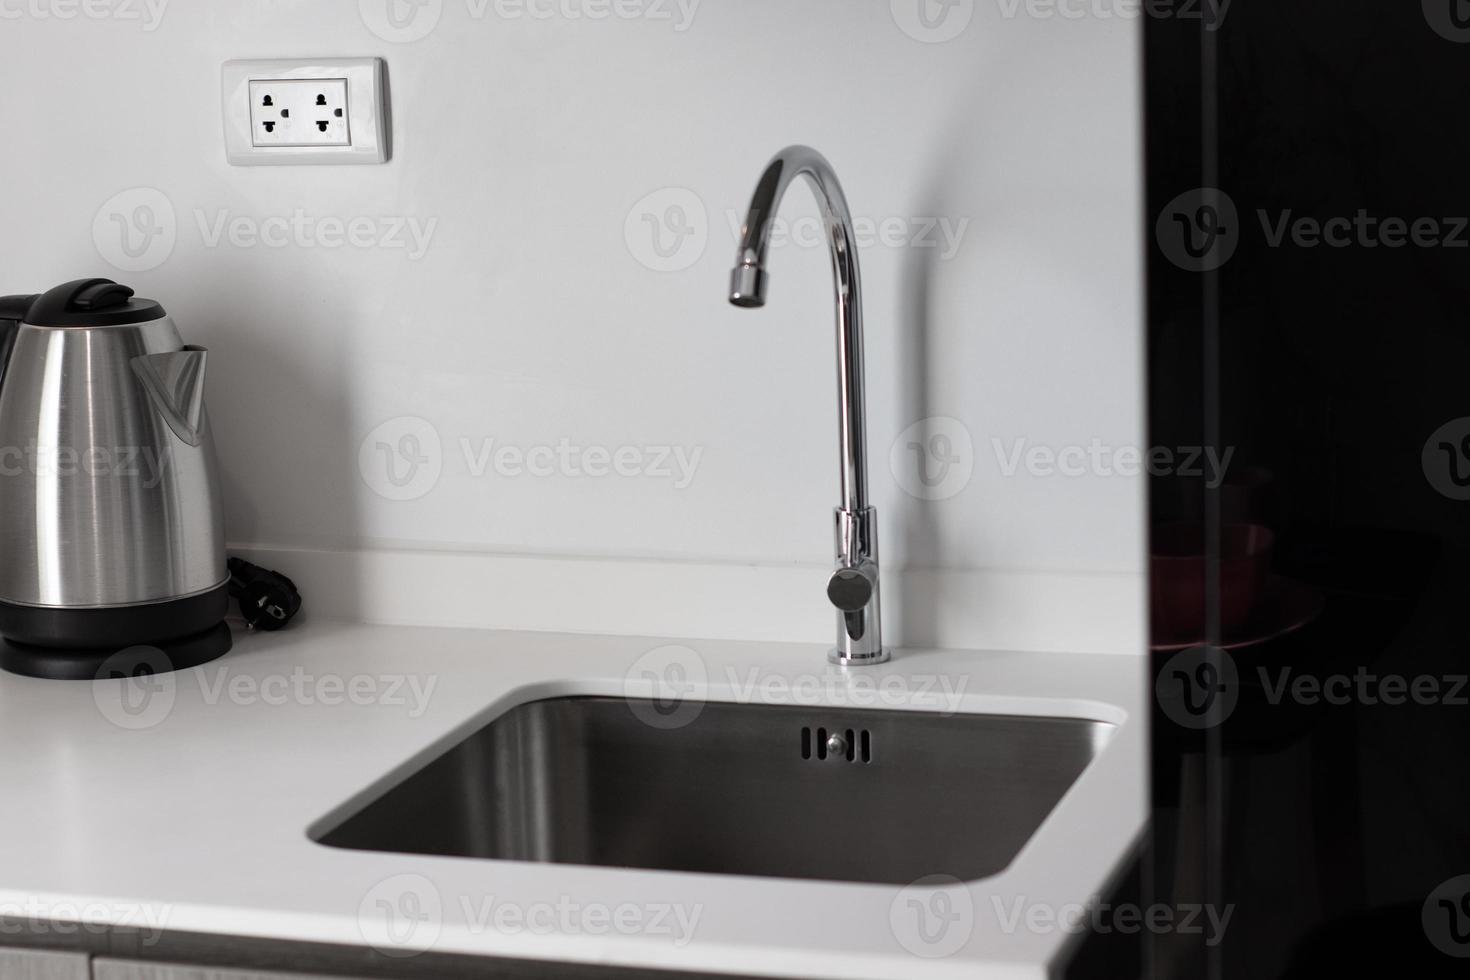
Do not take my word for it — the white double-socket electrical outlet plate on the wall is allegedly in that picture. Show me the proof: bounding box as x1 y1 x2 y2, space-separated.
221 57 388 166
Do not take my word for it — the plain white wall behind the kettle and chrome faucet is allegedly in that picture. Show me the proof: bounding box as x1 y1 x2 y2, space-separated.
0 0 1142 649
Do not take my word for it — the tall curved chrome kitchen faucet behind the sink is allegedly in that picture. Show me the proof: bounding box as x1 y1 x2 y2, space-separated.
731 145 888 667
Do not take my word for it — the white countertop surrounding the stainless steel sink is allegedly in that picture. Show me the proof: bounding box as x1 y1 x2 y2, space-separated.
0 621 1147 979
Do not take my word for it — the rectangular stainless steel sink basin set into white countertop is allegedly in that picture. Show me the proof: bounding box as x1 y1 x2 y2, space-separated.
316 698 1113 884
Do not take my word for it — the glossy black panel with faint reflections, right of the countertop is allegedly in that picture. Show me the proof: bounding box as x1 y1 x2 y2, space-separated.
1144 0 1470 979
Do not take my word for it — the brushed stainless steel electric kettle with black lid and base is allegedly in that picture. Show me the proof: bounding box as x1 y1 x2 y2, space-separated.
0 279 231 679
